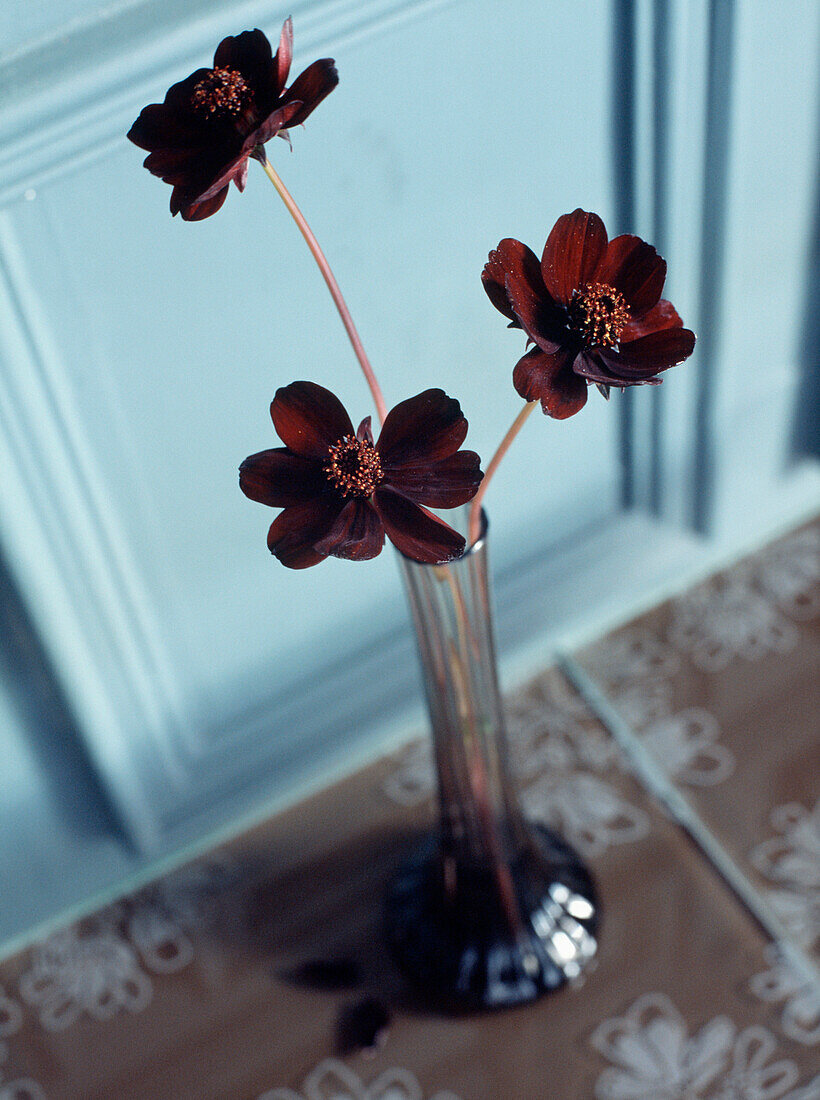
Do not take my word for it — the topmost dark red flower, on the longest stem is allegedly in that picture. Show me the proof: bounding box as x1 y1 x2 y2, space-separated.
128 19 339 221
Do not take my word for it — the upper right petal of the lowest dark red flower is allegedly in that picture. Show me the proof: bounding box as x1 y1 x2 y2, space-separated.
375 389 467 473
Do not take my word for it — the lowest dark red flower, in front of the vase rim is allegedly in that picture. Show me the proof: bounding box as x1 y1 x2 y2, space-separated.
239 382 483 569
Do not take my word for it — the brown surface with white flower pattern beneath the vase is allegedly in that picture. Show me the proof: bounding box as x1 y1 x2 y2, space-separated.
0 525 820 1100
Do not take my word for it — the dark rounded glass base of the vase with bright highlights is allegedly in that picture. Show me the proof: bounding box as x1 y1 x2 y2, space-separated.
385 825 599 1010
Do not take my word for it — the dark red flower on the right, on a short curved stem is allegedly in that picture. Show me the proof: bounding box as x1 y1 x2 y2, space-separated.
481 210 695 420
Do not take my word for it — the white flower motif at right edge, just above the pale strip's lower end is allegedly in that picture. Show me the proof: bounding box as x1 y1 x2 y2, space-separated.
750 801 820 949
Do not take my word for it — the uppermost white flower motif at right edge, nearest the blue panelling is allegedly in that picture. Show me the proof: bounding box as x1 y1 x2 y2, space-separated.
752 527 820 619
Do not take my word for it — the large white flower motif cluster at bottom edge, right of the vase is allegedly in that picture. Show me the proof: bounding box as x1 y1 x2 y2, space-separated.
590 993 799 1100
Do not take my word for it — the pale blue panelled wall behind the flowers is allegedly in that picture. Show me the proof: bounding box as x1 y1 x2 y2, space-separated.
0 0 820 944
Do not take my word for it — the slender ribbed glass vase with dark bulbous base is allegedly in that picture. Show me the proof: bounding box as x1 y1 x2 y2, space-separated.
385 509 599 1009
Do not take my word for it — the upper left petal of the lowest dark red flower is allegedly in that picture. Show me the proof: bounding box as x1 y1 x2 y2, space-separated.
271 382 353 461
